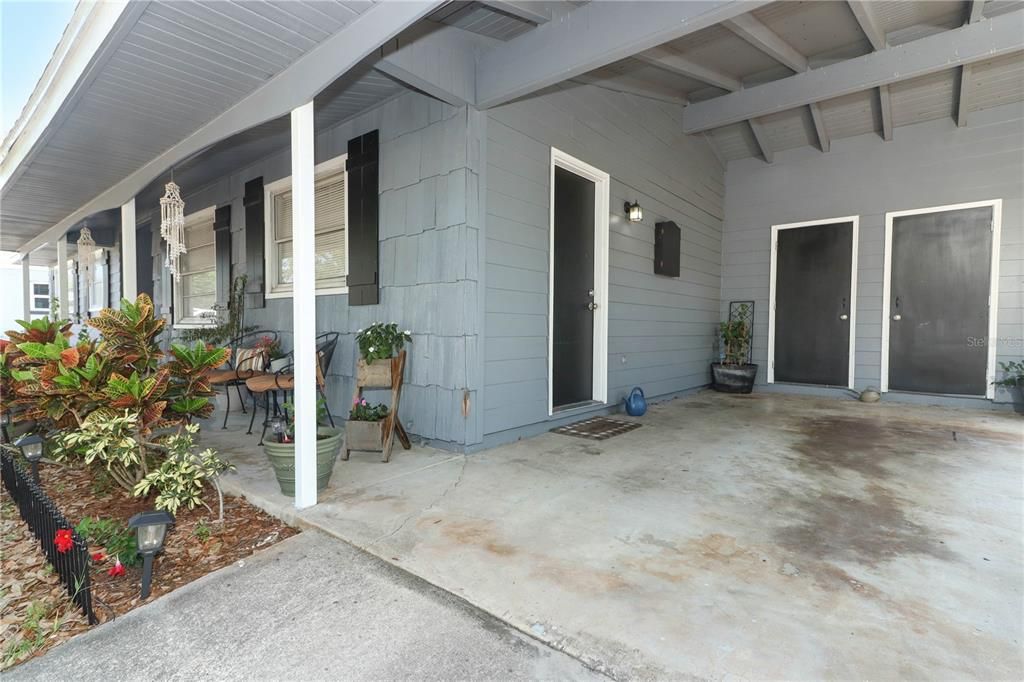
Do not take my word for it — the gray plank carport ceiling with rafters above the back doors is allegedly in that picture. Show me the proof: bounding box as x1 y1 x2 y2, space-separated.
574 0 1024 162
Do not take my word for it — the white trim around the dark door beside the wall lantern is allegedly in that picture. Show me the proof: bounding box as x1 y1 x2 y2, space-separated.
548 147 611 416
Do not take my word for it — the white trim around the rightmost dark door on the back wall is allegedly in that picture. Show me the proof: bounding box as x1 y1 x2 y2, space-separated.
879 199 1002 399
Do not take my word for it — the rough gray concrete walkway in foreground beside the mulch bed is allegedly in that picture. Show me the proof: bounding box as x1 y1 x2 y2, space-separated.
4 531 597 682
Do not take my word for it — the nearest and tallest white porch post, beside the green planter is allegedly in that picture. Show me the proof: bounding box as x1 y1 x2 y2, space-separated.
292 101 316 509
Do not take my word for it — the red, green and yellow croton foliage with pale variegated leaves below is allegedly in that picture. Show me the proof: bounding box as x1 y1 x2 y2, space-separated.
0 294 228 516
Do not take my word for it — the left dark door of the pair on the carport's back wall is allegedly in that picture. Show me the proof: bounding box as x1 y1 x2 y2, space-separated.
774 222 853 386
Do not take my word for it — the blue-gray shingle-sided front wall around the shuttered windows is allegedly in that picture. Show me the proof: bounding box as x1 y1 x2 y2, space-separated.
138 92 481 450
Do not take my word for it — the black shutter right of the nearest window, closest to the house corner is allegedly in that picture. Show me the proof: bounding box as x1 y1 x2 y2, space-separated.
345 130 380 305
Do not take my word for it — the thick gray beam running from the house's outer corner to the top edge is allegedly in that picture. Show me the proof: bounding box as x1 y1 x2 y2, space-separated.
476 0 768 109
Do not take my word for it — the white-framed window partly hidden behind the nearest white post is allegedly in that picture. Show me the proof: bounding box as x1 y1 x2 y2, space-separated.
264 155 348 298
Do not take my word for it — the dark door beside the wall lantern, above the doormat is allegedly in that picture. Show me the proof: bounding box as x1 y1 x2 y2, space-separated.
551 166 596 408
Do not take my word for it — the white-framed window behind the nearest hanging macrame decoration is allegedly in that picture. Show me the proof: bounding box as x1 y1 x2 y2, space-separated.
174 206 217 327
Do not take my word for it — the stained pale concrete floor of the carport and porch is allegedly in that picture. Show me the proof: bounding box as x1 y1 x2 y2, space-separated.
203 392 1024 679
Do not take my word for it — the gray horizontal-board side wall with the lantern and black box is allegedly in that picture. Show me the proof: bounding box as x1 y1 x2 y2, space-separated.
484 84 724 443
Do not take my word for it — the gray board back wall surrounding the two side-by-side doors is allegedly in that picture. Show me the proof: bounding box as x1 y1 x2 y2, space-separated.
722 103 1024 401
